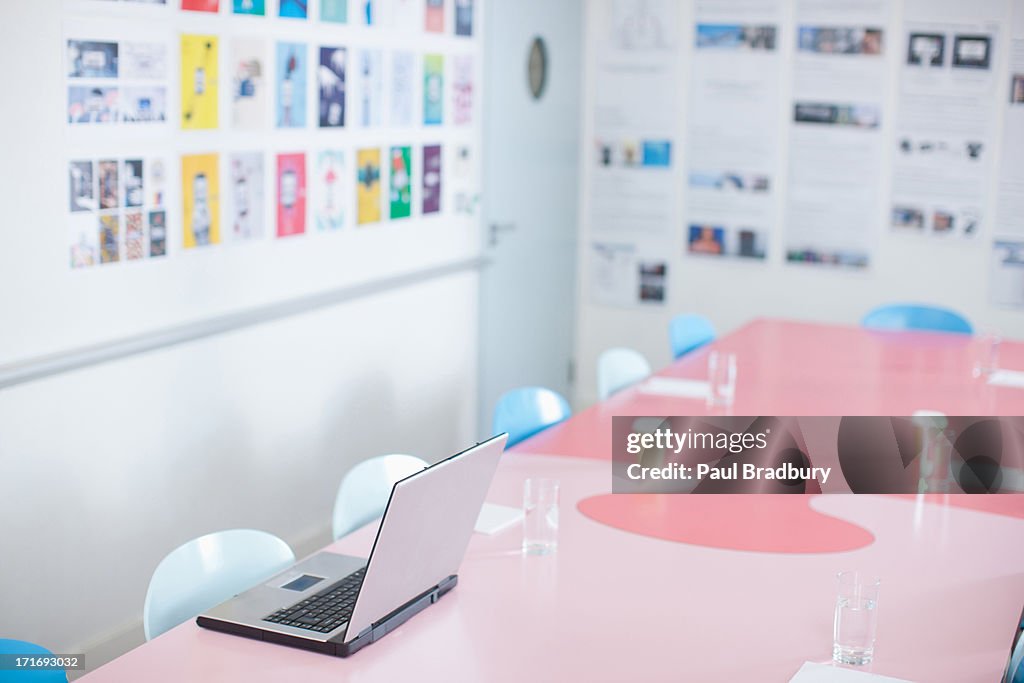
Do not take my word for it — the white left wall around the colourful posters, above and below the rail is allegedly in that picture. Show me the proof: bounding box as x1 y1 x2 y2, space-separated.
0 0 482 668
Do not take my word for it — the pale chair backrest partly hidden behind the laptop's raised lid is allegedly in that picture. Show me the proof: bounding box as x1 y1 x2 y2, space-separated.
332 453 427 541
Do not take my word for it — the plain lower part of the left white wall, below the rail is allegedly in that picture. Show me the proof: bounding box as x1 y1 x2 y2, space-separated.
0 272 478 668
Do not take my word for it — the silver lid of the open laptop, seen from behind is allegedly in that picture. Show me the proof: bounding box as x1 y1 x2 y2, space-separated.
345 434 508 642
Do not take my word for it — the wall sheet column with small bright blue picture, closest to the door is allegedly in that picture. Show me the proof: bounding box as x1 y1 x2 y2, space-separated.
585 0 682 305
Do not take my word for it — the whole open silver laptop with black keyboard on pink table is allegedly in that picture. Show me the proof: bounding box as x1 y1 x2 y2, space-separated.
196 434 508 656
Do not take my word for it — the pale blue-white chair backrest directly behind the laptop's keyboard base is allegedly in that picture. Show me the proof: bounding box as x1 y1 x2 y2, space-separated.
142 528 295 640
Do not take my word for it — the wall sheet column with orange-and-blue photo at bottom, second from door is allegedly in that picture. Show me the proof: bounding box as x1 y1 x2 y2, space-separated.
683 0 782 260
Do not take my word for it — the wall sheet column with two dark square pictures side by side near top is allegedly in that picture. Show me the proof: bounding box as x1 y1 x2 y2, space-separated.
890 0 1010 240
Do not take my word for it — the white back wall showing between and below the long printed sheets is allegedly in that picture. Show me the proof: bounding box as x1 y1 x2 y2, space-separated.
577 0 1024 405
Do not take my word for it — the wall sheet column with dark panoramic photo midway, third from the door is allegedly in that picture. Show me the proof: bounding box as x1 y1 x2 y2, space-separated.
785 0 893 267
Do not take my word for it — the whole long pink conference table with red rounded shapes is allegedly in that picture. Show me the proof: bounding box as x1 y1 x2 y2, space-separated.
83 321 1024 683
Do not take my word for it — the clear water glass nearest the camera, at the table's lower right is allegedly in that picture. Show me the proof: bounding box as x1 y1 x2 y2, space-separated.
833 571 880 666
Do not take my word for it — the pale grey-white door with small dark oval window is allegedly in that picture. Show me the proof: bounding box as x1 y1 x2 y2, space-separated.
479 0 584 434
